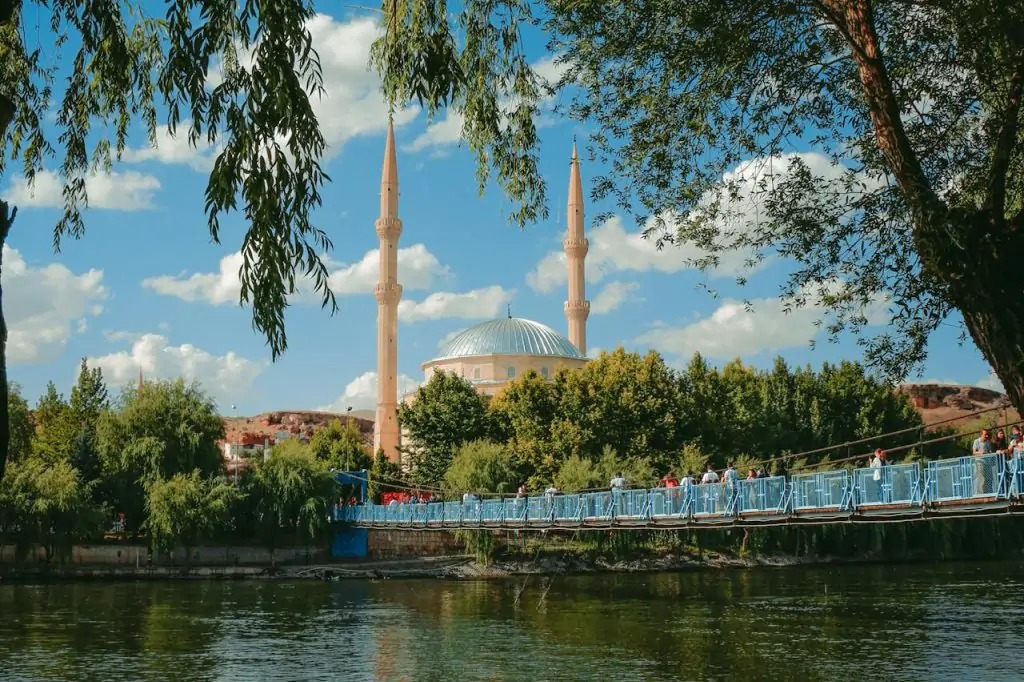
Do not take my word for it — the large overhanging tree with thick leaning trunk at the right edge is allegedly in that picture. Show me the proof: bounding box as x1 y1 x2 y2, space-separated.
373 0 1024 399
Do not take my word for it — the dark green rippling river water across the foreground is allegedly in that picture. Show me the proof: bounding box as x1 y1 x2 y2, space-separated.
0 562 1024 682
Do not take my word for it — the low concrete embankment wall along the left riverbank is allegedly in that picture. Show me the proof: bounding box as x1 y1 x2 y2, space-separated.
0 545 327 567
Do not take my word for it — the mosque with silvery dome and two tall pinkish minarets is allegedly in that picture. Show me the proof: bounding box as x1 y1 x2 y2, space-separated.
374 124 590 462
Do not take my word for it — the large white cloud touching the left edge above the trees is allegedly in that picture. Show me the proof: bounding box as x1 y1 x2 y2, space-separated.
3 244 108 365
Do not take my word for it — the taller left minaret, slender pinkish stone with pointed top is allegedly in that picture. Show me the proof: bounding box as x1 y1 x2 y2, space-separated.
374 122 401 462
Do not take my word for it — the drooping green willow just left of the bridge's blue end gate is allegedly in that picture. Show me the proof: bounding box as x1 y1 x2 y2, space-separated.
242 450 338 564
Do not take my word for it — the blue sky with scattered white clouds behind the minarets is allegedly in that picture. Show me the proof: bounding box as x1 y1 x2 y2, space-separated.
0 13 998 416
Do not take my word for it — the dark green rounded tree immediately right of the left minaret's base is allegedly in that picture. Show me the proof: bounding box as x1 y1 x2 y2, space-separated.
398 372 492 485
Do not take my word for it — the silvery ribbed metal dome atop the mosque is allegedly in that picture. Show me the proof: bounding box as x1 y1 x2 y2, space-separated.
434 317 585 361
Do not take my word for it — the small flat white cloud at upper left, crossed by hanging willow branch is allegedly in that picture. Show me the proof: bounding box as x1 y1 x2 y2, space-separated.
7 171 160 211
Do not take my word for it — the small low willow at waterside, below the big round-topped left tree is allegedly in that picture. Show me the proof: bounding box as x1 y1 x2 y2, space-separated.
145 469 238 566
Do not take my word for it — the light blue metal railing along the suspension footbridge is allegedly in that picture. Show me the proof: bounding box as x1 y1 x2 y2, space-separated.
335 454 1024 528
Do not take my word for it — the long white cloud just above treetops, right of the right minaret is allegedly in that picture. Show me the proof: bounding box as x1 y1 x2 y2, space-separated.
635 278 889 359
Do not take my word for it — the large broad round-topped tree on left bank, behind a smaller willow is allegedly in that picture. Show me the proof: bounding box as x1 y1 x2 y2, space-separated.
96 379 224 528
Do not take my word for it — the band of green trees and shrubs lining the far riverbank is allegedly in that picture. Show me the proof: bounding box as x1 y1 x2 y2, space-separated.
0 348 1024 580
